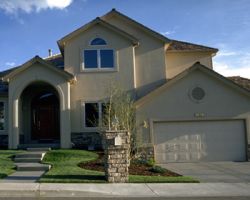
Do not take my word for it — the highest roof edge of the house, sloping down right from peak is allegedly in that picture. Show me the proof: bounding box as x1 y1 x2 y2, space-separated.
101 8 170 43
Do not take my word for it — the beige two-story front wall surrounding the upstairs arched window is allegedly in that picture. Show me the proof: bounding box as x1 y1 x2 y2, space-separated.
65 25 134 133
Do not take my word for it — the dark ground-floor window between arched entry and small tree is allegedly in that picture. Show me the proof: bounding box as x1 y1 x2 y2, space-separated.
85 102 107 128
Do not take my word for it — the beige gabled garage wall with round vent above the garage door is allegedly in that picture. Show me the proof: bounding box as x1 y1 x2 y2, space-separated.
136 70 250 145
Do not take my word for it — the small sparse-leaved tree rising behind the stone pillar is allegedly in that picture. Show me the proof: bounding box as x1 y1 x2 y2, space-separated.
103 86 136 155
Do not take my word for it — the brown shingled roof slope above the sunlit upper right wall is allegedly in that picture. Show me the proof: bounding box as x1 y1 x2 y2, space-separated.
167 40 218 53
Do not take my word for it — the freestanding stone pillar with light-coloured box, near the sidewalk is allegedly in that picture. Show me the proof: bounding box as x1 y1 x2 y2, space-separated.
103 131 130 183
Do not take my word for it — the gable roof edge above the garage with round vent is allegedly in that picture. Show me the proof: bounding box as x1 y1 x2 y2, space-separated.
135 62 250 107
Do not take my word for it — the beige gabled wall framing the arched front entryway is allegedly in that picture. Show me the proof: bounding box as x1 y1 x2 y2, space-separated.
9 63 71 149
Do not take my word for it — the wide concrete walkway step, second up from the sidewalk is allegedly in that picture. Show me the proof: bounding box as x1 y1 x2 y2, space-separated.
16 163 51 171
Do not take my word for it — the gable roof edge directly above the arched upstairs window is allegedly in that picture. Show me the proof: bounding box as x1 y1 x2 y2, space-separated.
57 17 139 54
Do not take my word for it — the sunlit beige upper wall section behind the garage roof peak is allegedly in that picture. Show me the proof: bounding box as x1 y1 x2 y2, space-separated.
166 52 213 79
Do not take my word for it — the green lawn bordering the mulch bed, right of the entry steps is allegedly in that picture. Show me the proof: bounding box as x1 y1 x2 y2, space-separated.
39 150 198 183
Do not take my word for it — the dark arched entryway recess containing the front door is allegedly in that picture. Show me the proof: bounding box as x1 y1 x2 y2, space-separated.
19 81 60 146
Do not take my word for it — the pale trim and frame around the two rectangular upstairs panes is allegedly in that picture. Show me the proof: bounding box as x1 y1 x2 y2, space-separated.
83 48 117 72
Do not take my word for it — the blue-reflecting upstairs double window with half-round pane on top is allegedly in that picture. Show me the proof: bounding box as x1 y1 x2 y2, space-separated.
83 38 114 69
